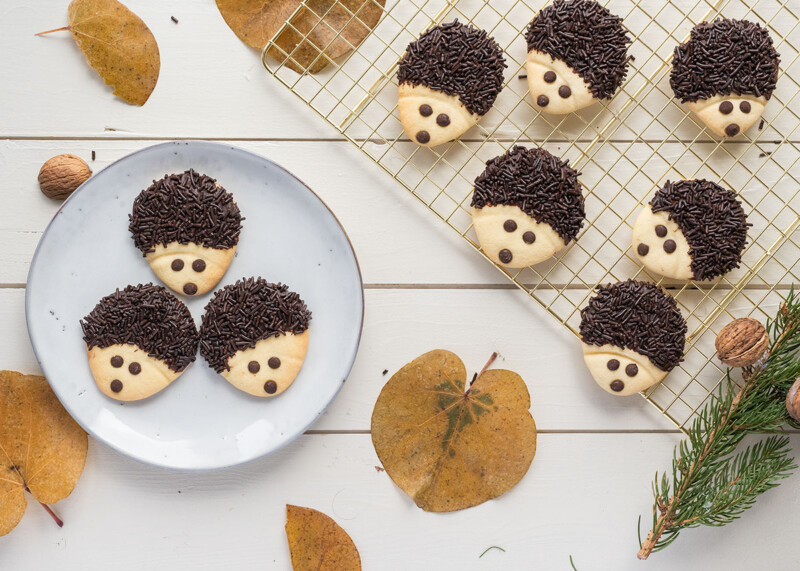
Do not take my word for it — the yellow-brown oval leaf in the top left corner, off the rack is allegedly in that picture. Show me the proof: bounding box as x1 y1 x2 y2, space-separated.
67 0 161 105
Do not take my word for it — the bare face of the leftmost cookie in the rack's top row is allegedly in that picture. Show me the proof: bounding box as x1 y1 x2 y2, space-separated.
397 83 480 147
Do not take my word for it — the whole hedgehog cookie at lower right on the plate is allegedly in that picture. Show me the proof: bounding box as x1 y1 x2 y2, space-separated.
200 278 311 397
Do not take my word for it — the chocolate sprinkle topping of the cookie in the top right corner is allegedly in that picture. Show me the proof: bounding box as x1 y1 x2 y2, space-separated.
669 18 780 103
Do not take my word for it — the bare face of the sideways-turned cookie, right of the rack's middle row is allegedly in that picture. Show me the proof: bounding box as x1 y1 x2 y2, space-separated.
633 204 694 280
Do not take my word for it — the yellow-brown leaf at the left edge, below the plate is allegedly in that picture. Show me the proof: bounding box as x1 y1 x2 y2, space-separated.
0 371 89 535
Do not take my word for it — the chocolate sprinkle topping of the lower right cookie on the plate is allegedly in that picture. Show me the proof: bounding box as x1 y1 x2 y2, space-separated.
200 278 311 373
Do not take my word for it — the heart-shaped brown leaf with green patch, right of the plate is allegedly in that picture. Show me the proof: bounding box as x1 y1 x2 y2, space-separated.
372 350 536 512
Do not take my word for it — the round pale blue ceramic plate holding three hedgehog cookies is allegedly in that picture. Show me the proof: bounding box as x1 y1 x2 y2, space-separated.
26 141 364 470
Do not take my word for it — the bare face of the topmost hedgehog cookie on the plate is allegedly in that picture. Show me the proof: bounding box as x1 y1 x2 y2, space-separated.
145 242 236 295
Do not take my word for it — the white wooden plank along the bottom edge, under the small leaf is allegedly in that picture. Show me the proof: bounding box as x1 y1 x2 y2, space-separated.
0 434 800 571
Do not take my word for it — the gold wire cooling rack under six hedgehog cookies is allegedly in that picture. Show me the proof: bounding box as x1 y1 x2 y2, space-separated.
262 0 800 430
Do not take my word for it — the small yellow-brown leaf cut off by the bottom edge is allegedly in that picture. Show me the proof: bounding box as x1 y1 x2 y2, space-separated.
286 505 361 571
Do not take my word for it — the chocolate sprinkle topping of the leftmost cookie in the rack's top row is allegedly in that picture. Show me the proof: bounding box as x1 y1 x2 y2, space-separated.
397 20 506 115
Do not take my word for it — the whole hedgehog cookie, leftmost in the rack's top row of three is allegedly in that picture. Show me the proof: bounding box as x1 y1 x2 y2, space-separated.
397 21 506 147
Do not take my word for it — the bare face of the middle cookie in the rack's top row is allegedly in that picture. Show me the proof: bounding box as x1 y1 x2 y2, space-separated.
525 50 597 115
